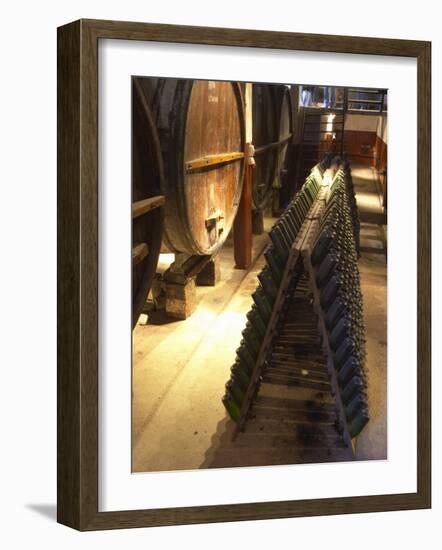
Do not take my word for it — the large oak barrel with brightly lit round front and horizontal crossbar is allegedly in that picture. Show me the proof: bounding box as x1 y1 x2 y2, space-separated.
137 77 245 255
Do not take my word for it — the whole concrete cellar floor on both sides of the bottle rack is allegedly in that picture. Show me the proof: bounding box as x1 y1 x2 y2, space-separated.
132 168 387 472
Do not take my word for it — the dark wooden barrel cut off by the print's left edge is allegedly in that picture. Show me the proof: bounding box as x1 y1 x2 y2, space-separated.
132 79 164 326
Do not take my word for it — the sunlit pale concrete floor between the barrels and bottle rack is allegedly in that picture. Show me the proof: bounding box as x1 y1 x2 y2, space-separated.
132 220 274 472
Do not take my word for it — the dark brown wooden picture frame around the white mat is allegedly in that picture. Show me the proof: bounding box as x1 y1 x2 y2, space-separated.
57 20 431 530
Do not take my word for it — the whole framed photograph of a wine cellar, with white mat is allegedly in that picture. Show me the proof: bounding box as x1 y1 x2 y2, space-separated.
57 20 431 530
